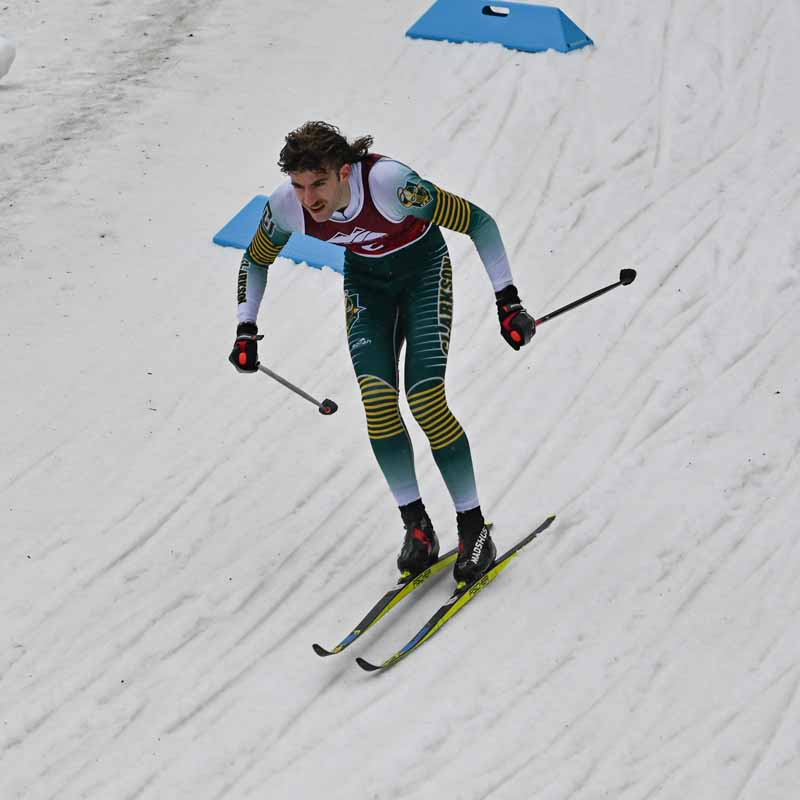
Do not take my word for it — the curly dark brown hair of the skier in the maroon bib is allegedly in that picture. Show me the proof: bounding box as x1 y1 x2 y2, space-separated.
278 122 372 173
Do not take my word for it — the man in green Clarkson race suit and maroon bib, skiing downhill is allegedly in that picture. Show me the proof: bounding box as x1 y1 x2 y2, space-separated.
230 122 535 584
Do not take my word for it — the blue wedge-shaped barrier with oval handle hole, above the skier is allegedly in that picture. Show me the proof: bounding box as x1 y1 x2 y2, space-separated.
406 0 594 53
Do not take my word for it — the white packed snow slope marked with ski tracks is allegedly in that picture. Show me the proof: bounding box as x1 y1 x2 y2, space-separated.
0 0 800 800
